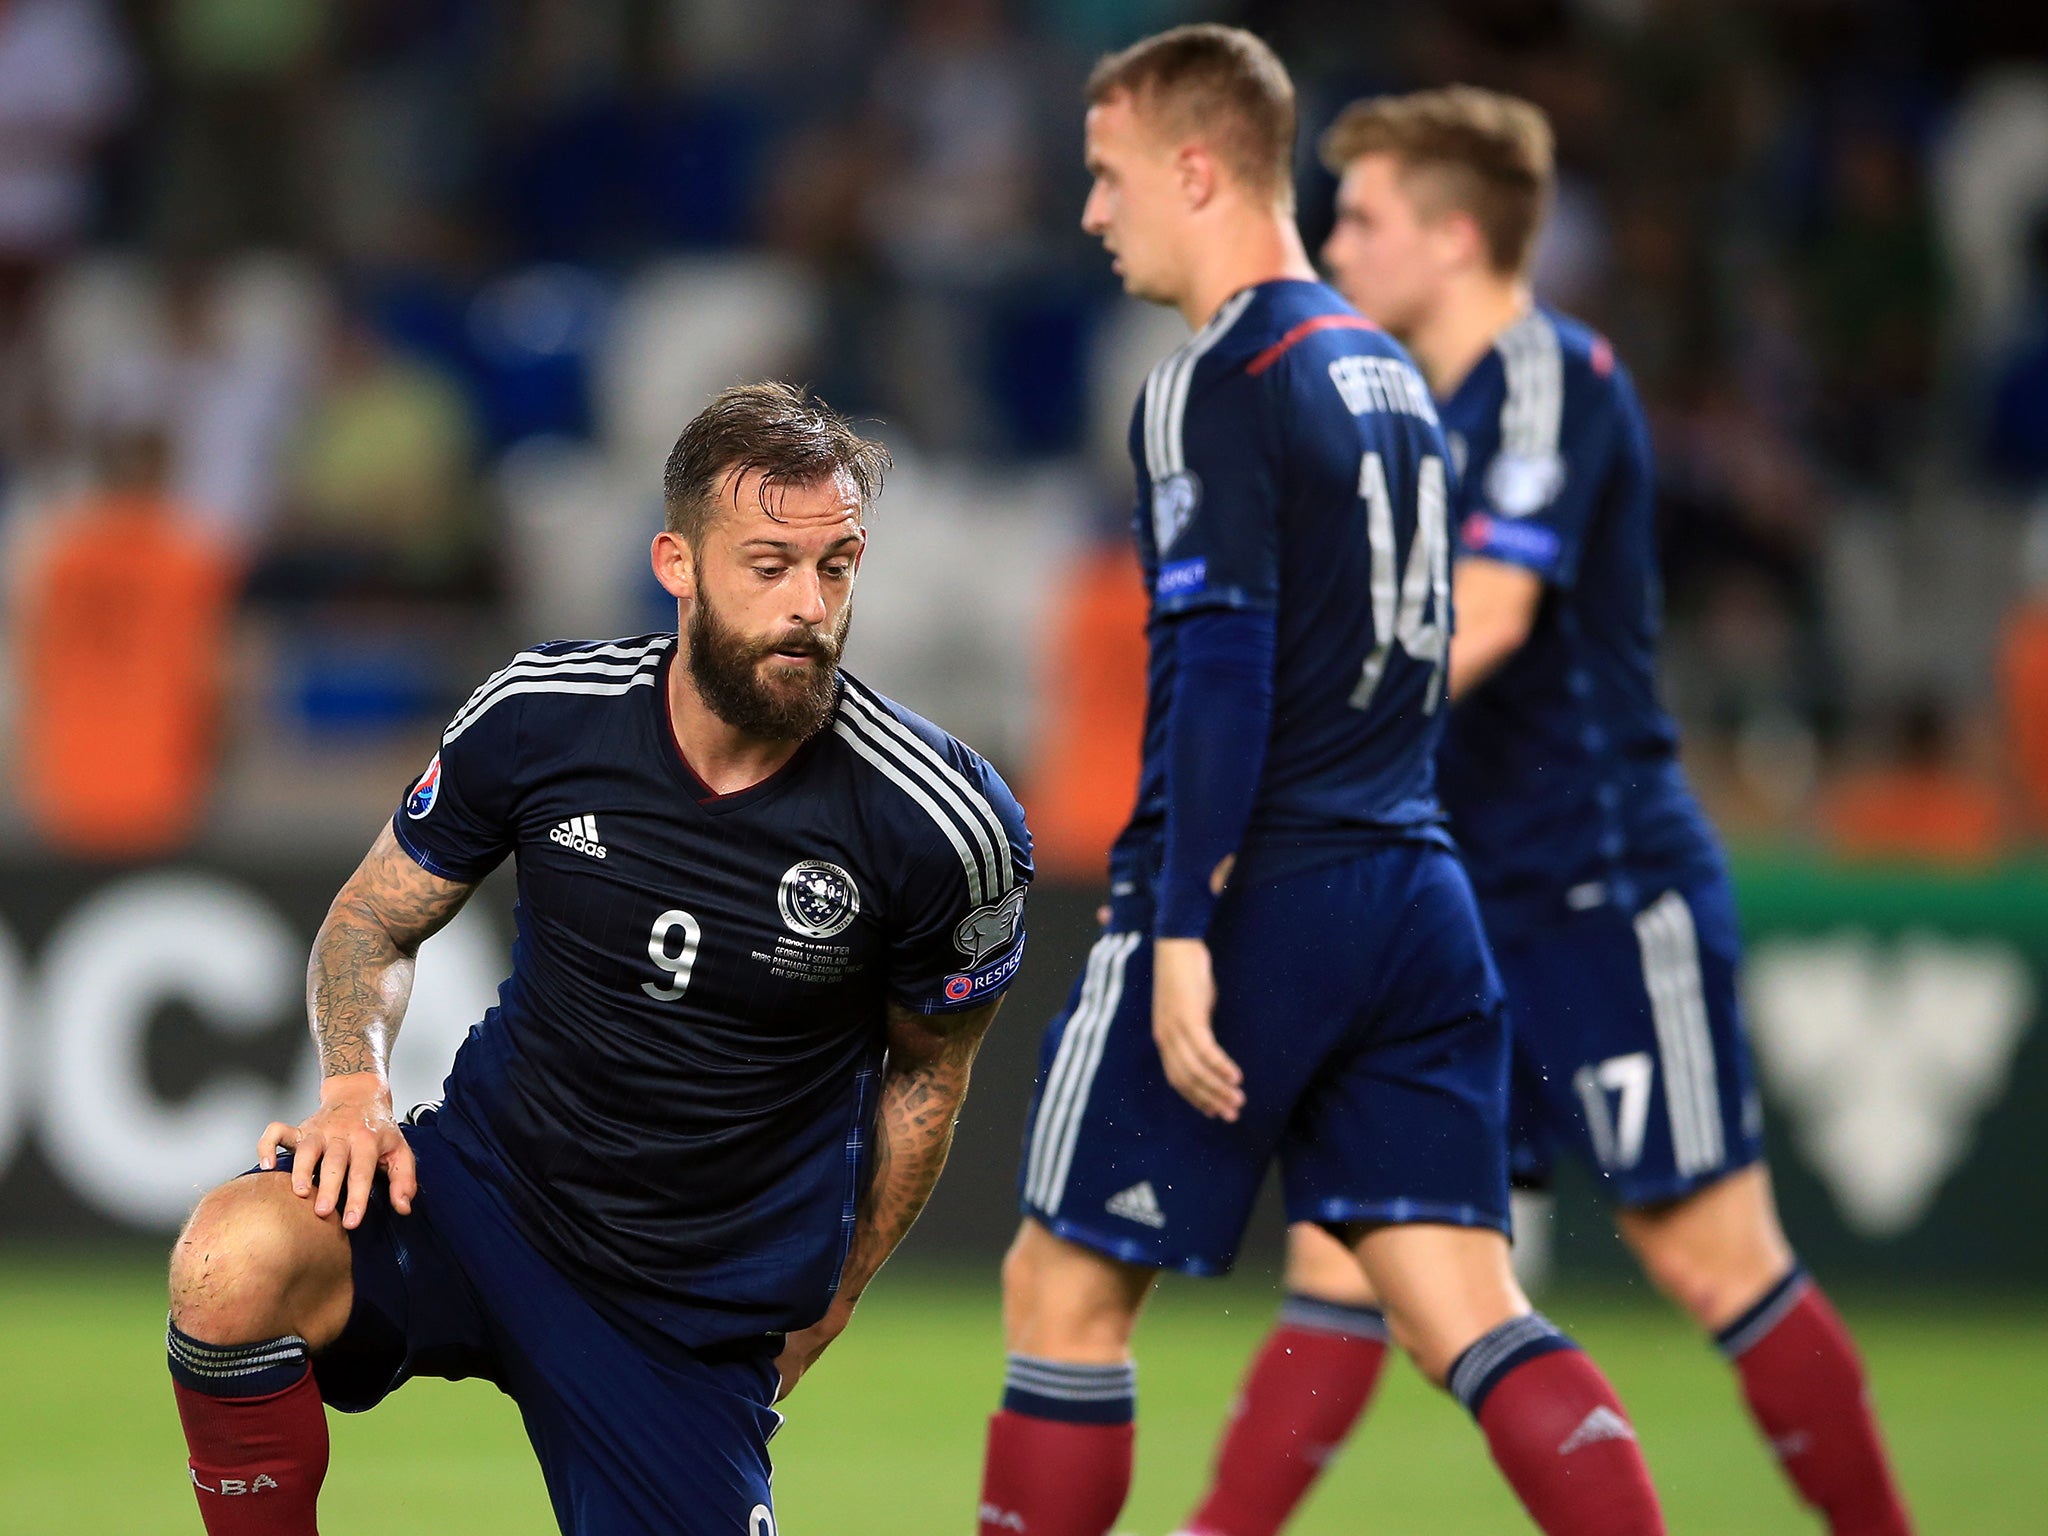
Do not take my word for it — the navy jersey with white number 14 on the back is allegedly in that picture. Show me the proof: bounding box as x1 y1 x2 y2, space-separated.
1112 281 1450 885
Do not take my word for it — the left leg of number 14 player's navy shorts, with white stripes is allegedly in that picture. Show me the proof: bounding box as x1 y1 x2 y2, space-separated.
1018 930 1290 1274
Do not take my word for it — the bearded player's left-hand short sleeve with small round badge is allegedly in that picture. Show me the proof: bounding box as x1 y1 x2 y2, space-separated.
391 690 520 885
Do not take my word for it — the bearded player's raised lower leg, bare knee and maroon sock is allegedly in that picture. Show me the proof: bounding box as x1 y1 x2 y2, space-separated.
166 1174 350 1536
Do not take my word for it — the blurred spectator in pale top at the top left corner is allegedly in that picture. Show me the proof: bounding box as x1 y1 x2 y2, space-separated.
0 0 133 471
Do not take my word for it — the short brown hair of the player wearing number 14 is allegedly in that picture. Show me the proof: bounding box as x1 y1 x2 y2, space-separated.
1087 23 1294 207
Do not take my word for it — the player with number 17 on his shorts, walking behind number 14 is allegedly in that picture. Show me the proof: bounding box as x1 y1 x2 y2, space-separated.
1186 86 1911 1536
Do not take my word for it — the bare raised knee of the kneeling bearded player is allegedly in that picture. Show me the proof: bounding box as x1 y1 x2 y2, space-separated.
170 1179 350 1350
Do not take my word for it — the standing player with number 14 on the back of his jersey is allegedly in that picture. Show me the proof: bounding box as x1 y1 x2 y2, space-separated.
979 27 1663 1536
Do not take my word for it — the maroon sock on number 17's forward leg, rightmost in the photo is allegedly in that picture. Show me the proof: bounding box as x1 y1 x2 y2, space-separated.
1718 1268 1913 1536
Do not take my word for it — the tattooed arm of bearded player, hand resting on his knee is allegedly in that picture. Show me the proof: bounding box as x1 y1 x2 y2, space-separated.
256 825 475 1227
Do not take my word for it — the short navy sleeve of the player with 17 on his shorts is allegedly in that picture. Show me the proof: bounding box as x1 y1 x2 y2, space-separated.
1458 379 1620 588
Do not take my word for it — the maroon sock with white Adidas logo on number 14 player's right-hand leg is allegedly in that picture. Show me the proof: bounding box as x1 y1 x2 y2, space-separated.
1448 1315 1665 1536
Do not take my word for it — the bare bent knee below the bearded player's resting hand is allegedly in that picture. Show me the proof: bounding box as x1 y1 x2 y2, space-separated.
170 1176 346 1343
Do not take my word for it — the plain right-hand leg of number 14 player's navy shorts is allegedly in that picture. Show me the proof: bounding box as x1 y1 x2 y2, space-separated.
1280 850 1507 1231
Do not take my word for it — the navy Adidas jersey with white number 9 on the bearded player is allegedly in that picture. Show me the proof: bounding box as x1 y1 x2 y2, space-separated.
391 635 1030 1346
